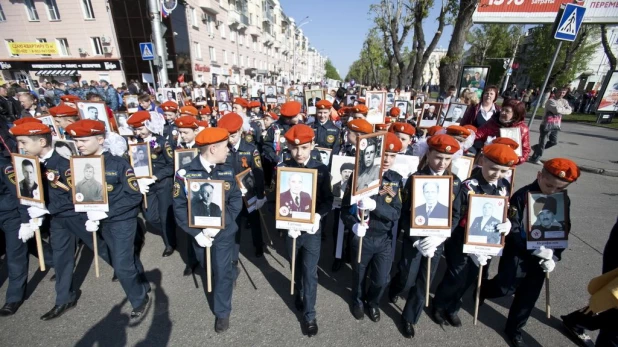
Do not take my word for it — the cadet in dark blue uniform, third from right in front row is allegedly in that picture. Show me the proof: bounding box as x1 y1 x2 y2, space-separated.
388 135 461 338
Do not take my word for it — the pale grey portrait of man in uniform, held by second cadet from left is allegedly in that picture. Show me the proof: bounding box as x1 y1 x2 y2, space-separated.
71 155 109 212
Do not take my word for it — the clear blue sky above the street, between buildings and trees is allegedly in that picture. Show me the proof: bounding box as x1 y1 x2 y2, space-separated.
280 0 453 78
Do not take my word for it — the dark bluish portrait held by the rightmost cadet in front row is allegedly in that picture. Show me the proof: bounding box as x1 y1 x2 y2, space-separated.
526 191 570 249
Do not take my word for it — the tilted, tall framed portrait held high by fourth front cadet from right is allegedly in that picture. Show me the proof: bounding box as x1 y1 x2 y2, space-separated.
351 131 386 203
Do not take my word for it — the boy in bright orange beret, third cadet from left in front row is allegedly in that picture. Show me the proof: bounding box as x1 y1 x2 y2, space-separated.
174 128 243 333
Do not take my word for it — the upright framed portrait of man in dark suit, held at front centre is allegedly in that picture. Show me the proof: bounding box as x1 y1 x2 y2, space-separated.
275 167 318 230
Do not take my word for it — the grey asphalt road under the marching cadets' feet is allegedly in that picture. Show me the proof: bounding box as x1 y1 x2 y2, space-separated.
0 128 618 347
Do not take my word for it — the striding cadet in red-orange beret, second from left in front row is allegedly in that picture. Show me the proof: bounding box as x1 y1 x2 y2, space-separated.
66 120 150 318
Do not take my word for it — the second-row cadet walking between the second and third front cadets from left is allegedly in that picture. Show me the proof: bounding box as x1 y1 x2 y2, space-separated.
127 110 176 257
